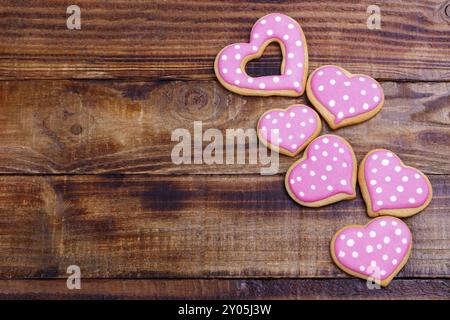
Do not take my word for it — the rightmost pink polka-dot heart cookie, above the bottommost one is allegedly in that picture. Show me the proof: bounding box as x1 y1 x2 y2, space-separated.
358 149 432 218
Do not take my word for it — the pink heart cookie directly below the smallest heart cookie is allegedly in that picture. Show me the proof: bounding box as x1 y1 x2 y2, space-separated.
285 134 357 207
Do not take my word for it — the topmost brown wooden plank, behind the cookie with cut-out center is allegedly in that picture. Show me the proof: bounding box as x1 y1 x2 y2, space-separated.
0 0 450 81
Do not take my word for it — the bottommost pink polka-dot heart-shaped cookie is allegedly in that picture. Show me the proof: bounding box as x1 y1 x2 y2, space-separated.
331 217 412 286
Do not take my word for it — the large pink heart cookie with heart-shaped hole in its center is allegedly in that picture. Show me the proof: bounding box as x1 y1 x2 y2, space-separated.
214 13 308 97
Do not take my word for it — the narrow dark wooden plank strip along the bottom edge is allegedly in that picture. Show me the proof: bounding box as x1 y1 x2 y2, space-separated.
0 279 450 300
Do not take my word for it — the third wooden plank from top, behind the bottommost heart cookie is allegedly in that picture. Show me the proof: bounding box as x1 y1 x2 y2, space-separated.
0 175 450 279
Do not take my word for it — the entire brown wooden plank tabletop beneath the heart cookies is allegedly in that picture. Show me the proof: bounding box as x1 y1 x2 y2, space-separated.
0 0 450 299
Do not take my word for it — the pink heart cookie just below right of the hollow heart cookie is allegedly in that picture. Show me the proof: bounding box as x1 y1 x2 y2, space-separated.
306 65 384 129
